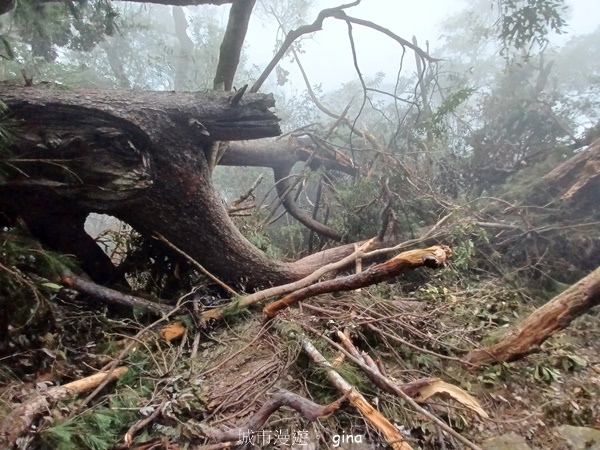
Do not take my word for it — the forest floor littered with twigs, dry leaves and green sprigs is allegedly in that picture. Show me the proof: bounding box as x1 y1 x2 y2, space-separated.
0 271 600 449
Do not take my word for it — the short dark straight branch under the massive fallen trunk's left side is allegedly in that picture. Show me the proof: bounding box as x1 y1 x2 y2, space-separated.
62 274 173 315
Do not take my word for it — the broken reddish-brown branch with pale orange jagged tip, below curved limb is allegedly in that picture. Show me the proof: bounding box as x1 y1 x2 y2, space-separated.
263 245 452 318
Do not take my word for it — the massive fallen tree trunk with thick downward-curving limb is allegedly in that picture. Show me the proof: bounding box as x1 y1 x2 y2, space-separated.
0 84 352 288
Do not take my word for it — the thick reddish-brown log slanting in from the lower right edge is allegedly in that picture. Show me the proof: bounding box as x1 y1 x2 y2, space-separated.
465 267 600 365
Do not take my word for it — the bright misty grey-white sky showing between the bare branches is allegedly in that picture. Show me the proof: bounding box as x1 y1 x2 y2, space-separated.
247 0 600 90
